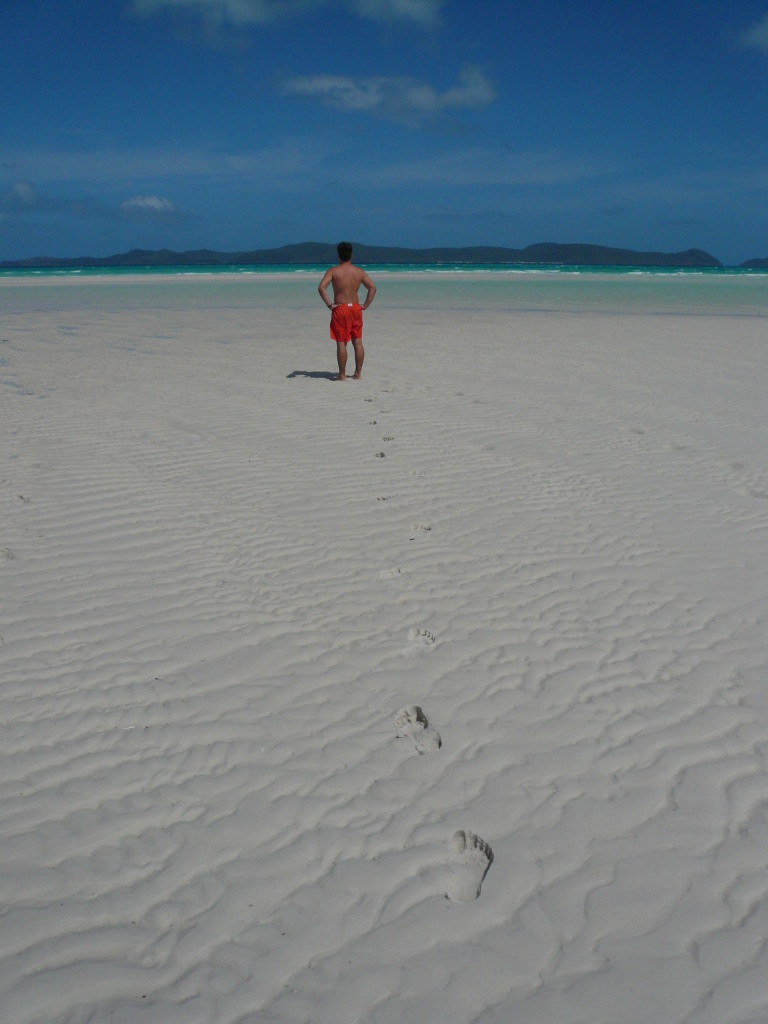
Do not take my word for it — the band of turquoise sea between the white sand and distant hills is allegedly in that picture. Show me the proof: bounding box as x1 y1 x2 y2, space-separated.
0 264 768 316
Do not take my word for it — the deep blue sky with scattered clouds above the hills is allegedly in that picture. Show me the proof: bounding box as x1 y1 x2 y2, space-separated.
0 0 768 263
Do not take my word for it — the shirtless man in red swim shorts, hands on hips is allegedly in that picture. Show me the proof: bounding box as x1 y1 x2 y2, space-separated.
317 242 376 381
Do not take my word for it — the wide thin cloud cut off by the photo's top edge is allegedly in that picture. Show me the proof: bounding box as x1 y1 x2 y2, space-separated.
132 0 444 28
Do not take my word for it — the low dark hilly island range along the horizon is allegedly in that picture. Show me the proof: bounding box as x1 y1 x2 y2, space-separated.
0 242 768 270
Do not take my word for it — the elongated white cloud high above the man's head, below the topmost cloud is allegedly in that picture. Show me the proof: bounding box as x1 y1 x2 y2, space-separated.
282 68 496 124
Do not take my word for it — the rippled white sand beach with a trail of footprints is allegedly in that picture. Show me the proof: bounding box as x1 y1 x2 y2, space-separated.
0 282 768 1024
